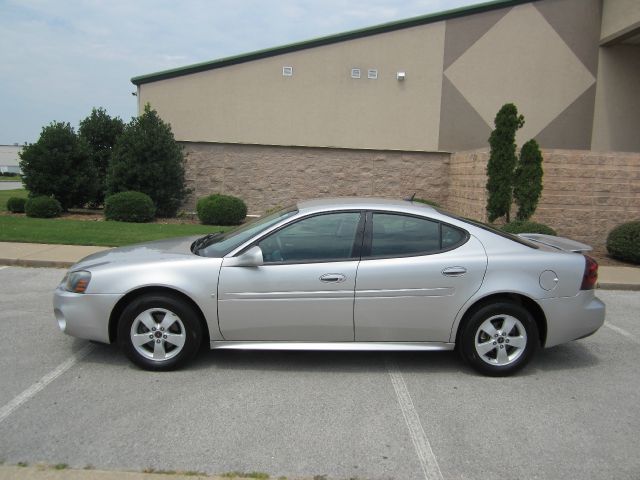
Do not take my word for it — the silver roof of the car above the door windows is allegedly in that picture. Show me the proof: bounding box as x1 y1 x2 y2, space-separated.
297 197 434 213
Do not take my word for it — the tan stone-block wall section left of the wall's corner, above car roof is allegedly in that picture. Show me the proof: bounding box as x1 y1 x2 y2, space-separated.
184 143 449 214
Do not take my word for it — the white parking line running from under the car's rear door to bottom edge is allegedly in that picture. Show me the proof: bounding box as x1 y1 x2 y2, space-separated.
387 360 442 480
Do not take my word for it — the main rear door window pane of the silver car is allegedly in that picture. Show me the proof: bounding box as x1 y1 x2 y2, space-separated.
371 213 440 257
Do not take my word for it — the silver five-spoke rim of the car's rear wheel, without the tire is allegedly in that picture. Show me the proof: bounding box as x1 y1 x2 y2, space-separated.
474 315 527 366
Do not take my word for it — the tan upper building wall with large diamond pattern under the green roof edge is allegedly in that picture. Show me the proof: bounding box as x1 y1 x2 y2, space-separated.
138 0 601 151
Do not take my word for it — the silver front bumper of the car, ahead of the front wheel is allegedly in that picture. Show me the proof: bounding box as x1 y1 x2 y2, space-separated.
53 288 122 343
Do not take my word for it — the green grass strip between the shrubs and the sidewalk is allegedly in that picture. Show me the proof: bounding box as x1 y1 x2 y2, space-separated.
0 215 231 247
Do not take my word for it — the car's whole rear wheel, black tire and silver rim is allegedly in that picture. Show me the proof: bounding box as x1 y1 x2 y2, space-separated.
458 302 540 377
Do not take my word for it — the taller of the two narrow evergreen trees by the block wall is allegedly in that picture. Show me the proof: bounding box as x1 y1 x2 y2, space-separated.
487 103 524 223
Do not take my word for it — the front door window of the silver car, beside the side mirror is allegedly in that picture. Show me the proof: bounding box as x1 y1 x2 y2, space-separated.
258 212 360 263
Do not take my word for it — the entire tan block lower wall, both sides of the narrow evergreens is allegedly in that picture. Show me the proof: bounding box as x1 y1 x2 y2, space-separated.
184 143 640 247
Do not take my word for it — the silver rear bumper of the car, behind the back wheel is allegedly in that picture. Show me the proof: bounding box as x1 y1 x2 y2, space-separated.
538 290 605 347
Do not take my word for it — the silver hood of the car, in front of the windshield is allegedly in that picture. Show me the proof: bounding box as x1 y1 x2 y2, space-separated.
71 235 201 270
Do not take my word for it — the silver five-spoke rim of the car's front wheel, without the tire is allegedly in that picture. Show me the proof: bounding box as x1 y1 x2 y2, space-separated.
130 308 187 362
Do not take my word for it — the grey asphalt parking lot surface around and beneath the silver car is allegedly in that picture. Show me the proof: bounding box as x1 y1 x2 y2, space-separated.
0 267 640 480
